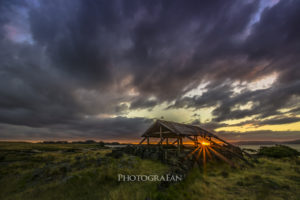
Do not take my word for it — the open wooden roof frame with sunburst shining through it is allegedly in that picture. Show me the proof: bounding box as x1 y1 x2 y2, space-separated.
139 120 249 167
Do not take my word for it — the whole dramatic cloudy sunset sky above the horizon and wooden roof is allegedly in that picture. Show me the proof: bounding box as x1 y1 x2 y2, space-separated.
0 0 300 141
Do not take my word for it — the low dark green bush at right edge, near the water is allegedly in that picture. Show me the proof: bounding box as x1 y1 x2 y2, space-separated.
257 145 299 158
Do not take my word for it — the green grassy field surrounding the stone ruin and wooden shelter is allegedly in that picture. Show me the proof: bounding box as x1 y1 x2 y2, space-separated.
0 142 300 200
